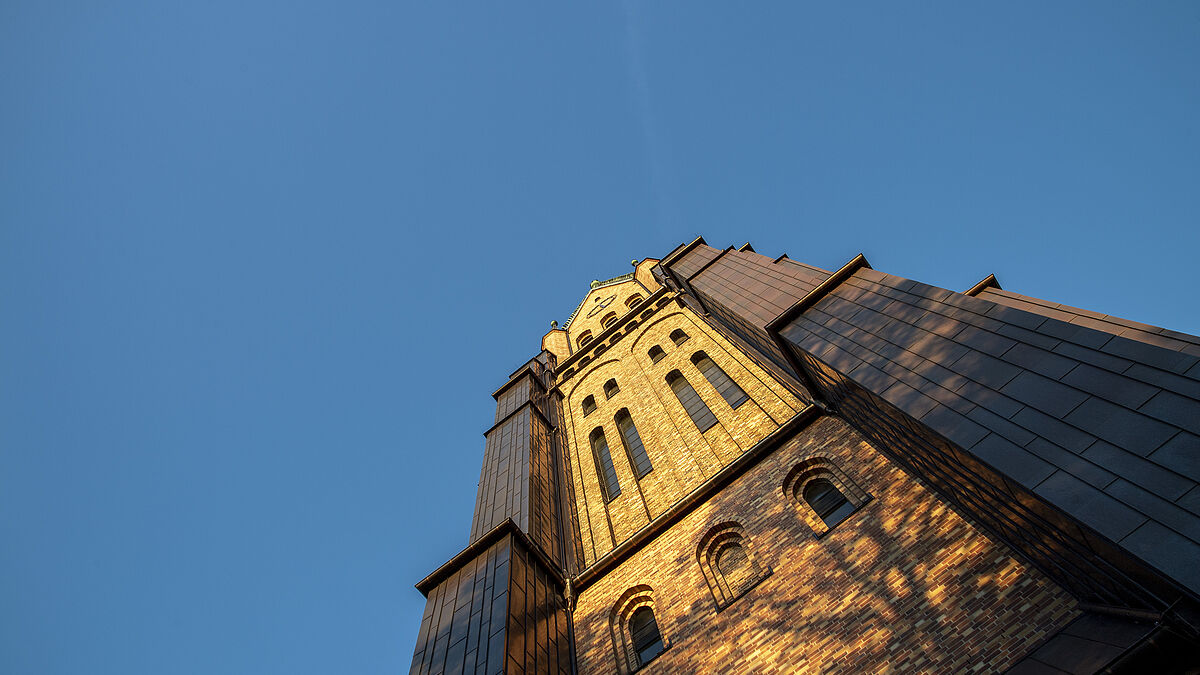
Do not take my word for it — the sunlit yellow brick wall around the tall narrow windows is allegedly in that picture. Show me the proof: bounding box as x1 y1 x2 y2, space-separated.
558 289 803 565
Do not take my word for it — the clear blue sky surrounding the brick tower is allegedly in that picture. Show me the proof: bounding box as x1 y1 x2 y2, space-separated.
0 0 1200 675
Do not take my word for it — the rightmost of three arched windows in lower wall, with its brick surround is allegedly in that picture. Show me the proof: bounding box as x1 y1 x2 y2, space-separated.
784 453 871 537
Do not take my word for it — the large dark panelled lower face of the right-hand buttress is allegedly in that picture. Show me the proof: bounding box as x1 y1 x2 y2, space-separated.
785 269 1200 590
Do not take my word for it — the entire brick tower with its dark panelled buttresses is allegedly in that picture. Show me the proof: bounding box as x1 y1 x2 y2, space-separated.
410 239 1200 675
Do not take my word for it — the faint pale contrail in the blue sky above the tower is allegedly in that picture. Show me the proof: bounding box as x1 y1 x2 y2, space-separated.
622 0 678 234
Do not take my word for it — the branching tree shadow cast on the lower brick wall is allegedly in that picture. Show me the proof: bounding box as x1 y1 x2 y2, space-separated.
678 451 1074 673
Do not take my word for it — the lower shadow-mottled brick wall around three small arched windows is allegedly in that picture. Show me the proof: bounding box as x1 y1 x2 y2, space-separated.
574 415 1078 675
